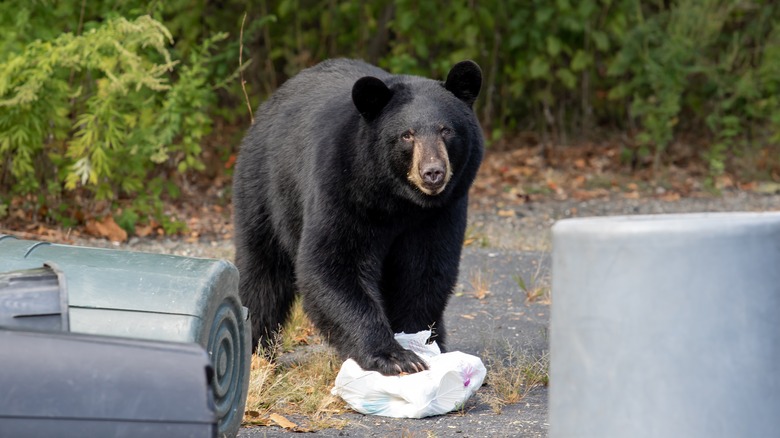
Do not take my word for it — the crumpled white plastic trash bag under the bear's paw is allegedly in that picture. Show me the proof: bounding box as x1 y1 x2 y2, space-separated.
331 330 487 418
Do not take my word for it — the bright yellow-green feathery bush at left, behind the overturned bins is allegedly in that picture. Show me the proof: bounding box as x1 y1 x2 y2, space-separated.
0 8 226 229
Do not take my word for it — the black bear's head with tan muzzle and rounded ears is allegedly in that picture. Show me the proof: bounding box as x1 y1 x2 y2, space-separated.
352 61 483 205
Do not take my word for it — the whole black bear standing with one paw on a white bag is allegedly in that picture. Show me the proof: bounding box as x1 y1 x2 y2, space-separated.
233 59 484 375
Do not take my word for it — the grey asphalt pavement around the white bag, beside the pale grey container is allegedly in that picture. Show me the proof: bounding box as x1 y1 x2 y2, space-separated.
238 247 550 438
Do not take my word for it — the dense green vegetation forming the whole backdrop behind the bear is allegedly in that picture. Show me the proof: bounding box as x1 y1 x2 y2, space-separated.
0 0 780 231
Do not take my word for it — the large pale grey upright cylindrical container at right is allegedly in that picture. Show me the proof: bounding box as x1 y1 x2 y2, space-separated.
549 213 780 438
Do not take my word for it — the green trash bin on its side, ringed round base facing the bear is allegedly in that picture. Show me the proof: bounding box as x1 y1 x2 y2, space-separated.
0 235 251 436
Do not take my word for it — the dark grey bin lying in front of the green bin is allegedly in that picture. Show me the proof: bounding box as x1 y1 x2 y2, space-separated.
0 329 217 438
